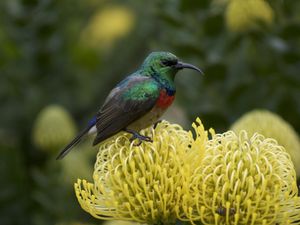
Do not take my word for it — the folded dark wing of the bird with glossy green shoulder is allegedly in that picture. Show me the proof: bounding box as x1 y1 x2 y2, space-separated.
93 76 159 145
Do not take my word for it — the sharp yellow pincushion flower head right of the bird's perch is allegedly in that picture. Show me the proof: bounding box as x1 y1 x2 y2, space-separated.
181 131 300 224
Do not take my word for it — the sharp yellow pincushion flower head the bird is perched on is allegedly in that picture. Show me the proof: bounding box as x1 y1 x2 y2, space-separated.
75 121 207 224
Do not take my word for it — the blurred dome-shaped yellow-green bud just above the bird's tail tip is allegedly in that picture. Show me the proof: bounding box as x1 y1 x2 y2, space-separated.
33 105 76 152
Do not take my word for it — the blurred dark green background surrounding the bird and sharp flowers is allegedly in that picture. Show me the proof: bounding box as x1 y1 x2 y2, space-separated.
0 0 300 225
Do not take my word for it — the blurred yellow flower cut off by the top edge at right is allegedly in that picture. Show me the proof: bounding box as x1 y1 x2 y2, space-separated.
225 0 274 32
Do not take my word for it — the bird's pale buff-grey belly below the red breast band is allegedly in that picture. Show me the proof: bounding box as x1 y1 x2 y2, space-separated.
127 107 166 131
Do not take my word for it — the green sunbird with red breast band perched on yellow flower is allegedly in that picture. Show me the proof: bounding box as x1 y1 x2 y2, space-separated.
56 51 203 159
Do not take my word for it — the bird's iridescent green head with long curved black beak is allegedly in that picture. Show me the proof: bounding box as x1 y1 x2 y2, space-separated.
142 52 203 80
